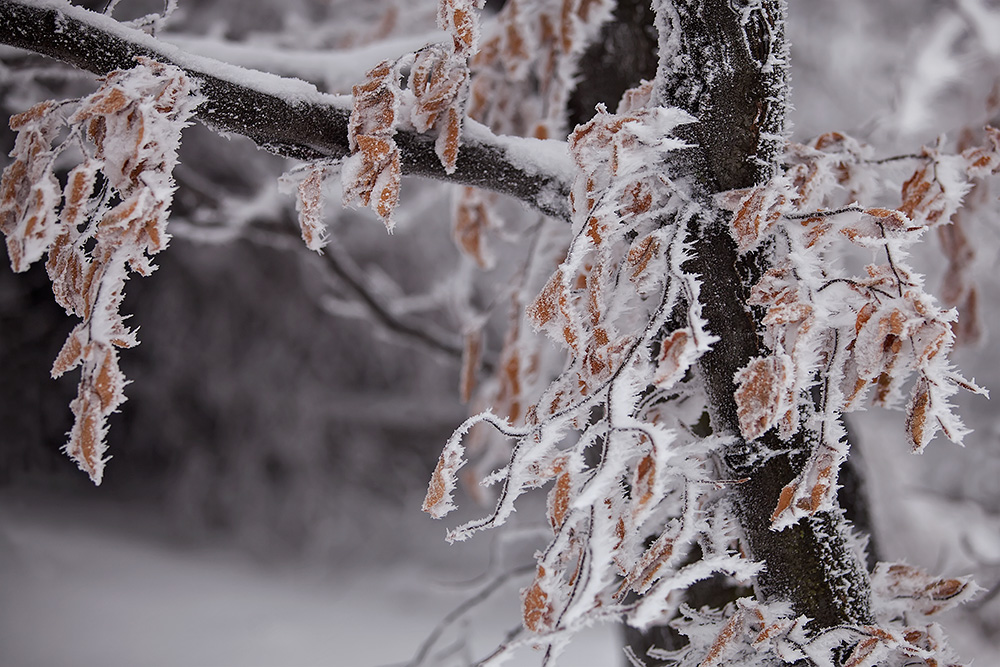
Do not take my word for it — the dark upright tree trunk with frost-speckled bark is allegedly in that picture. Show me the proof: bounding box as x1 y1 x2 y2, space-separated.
657 0 874 630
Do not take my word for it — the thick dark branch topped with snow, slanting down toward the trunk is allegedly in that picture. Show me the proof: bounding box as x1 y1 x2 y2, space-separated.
0 0 572 220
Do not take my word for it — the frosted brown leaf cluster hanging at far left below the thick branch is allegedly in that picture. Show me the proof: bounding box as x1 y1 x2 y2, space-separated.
0 59 197 483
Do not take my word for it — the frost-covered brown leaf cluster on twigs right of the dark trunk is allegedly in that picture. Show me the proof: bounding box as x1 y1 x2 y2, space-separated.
723 128 1000 525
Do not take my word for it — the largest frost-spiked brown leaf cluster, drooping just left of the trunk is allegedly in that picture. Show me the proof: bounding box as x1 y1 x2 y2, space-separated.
425 96 735 648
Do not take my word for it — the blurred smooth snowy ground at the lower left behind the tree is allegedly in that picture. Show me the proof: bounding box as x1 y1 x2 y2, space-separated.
0 499 622 667
